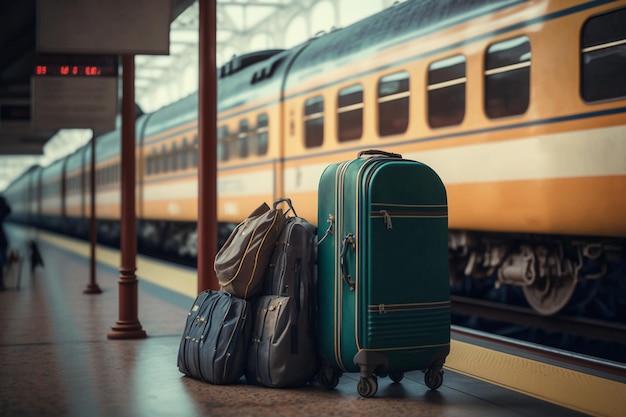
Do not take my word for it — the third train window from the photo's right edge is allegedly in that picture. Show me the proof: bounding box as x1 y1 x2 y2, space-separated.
428 55 467 127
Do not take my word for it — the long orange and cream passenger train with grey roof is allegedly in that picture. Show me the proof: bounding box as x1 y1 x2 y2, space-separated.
4 0 626 315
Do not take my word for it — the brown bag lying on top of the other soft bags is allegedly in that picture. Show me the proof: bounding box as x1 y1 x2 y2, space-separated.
214 200 286 299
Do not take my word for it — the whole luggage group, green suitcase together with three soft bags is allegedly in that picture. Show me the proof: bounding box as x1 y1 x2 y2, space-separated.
178 150 450 397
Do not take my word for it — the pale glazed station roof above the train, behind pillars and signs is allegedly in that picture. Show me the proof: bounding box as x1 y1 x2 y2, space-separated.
0 0 368 190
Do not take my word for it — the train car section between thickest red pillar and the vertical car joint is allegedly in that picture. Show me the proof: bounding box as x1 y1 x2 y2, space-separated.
217 47 294 222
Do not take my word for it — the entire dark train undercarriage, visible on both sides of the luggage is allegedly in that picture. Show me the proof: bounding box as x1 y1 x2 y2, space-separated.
25 213 626 320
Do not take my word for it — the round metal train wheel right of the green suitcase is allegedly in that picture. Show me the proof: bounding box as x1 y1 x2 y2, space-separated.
524 274 576 316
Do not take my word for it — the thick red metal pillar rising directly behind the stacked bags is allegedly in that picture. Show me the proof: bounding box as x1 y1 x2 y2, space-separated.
198 0 219 293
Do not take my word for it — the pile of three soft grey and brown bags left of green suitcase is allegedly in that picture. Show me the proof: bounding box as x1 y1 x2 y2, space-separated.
178 199 318 388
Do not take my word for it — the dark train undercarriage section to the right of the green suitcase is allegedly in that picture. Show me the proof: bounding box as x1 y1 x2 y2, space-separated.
448 231 626 316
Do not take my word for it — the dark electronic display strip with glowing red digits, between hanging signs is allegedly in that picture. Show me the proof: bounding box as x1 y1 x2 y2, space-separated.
33 54 118 77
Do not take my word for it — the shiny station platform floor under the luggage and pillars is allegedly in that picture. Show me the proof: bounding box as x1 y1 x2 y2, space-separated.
0 224 626 417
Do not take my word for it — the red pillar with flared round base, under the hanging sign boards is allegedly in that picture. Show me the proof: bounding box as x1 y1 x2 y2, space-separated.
107 55 146 339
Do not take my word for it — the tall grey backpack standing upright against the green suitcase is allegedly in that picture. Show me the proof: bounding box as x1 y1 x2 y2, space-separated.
246 203 318 388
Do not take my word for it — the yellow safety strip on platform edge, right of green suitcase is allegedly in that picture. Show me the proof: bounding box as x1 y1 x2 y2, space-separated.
445 340 626 417
